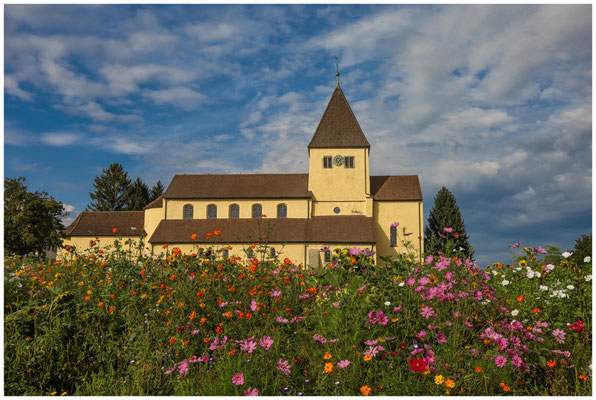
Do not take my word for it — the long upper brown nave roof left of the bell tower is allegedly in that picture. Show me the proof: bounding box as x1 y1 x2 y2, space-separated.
163 174 310 199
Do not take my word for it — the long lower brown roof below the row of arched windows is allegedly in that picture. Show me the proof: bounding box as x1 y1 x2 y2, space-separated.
149 216 375 243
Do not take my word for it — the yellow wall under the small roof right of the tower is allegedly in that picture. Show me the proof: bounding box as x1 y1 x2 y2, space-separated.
373 201 424 264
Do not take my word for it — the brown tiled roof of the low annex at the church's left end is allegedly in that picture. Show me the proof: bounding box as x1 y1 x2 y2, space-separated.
64 211 145 236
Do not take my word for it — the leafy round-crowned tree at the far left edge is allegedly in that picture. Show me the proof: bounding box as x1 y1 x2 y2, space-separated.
4 176 67 255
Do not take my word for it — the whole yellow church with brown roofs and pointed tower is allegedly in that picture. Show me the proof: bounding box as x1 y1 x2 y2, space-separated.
64 84 423 268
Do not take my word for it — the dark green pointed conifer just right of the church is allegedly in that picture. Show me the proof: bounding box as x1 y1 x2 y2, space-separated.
424 187 474 259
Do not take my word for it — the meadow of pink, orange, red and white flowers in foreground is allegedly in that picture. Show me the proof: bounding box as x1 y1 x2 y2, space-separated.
4 232 592 396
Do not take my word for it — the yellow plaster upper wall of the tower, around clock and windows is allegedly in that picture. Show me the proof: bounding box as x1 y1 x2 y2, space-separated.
308 148 370 202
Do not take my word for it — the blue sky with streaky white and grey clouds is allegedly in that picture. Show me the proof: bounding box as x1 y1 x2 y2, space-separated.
4 5 592 265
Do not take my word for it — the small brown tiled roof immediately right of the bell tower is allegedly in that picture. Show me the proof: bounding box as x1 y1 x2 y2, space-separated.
370 175 422 201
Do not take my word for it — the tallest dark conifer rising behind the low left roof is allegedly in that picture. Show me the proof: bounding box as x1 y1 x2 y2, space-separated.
87 163 130 211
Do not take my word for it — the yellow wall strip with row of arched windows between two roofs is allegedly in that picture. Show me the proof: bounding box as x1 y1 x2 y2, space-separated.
166 199 308 219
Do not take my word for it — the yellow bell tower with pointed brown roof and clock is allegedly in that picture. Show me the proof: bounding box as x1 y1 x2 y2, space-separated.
308 84 372 216
